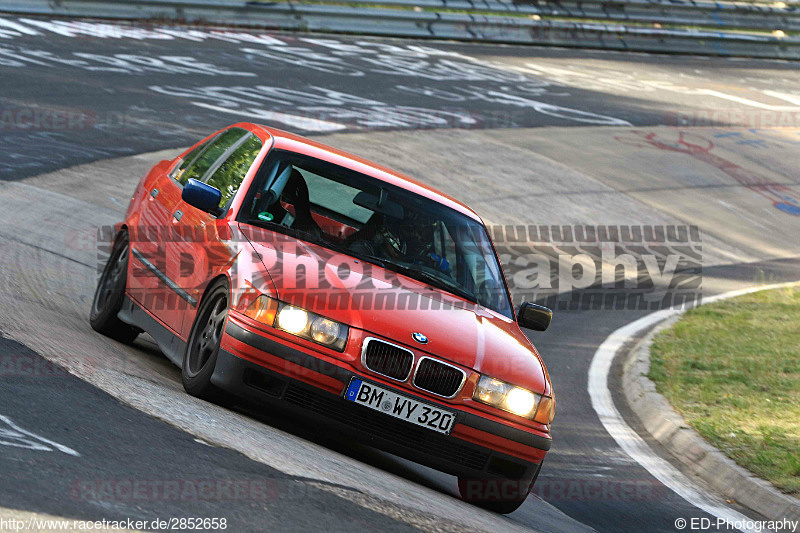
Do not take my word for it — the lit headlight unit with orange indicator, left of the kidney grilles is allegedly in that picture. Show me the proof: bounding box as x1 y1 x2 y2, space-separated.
244 295 349 352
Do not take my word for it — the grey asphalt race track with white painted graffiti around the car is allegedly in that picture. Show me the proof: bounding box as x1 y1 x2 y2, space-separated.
0 17 800 532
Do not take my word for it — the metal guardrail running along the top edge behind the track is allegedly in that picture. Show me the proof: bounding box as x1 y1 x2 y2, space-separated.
0 0 800 59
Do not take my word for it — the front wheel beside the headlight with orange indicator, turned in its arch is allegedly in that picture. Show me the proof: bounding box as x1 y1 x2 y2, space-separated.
181 280 230 401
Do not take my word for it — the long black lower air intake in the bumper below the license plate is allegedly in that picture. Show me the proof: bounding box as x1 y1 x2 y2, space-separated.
283 383 489 470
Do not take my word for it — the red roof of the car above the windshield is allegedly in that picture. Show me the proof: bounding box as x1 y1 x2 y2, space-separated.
245 123 483 223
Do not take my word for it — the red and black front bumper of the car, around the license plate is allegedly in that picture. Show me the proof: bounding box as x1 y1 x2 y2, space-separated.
212 320 551 482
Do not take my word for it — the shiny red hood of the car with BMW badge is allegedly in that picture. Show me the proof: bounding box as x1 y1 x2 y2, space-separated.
242 225 550 394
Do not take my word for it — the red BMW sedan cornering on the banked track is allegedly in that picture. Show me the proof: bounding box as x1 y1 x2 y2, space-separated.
90 123 555 513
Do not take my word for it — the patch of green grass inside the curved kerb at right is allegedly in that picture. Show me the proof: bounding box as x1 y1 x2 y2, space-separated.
649 288 800 495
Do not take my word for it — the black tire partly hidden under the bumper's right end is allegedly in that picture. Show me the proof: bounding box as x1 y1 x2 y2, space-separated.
458 463 542 514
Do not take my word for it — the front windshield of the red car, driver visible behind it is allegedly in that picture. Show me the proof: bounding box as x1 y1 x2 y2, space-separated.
238 150 513 318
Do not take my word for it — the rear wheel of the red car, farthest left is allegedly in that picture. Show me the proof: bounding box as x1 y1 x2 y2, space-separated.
89 231 141 344
